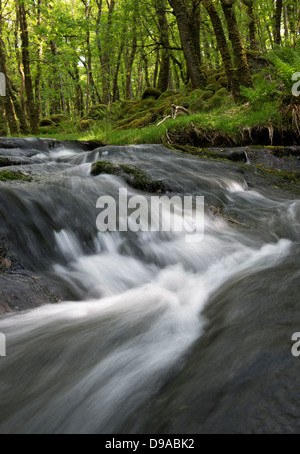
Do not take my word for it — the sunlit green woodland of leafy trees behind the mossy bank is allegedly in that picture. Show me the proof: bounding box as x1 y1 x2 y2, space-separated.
0 0 300 135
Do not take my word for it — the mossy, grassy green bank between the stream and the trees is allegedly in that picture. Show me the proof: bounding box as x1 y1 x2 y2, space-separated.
27 68 300 148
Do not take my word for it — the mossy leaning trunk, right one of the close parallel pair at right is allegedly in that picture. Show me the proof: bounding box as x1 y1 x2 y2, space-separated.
221 0 253 88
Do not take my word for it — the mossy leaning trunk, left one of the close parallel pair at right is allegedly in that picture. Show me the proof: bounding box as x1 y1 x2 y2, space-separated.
203 0 240 100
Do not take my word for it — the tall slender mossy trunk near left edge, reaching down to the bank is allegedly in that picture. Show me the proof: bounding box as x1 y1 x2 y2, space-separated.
17 0 39 134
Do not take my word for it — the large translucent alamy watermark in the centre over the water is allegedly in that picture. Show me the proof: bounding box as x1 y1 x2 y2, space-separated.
96 188 204 243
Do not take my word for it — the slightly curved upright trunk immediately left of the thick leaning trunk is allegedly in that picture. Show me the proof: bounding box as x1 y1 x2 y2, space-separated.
154 0 170 92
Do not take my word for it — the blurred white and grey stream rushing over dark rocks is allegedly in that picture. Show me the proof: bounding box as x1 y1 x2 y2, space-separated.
0 139 300 434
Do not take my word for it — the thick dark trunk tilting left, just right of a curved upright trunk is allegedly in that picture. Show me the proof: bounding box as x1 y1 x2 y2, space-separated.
169 0 206 89
